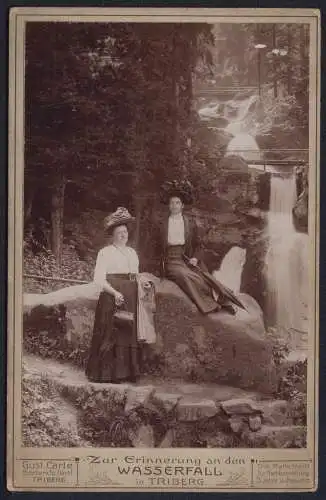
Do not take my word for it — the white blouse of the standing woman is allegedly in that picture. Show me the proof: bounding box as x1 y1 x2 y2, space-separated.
94 245 139 285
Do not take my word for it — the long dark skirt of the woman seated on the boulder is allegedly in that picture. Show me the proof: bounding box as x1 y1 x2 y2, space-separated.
164 245 222 314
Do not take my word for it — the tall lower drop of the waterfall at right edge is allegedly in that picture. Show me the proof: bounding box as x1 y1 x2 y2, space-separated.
265 175 308 331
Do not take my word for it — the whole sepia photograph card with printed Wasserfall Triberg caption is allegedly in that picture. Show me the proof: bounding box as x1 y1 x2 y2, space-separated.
9 9 319 489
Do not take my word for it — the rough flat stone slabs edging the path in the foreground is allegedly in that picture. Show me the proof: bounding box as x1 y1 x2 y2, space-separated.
24 356 306 447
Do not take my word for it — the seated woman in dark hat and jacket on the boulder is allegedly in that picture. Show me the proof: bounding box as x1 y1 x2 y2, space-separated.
159 181 241 315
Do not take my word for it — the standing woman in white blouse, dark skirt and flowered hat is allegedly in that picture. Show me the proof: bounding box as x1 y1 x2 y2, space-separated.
86 207 139 383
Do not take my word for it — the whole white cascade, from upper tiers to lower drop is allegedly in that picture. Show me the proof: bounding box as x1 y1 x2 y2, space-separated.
199 91 309 344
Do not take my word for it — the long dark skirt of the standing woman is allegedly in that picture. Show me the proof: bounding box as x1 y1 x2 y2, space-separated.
86 275 139 383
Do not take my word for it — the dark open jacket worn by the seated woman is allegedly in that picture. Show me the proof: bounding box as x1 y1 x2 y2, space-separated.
158 214 201 277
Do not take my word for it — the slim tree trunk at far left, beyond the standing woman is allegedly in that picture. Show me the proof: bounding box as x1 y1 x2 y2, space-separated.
51 176 66 266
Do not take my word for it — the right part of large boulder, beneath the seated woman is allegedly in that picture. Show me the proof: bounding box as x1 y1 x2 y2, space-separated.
156 280 275 392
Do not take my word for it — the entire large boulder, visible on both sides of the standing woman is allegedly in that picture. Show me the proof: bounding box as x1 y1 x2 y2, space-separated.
24 276 275 392
